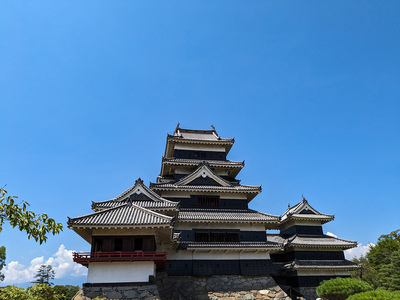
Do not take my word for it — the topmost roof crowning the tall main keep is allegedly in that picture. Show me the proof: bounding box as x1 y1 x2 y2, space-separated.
164 123 235 157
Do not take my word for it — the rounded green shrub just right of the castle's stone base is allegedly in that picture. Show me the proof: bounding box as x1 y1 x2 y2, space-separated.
317 277 372 300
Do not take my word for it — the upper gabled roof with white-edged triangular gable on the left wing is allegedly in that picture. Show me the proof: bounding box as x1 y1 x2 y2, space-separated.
92 178 178 211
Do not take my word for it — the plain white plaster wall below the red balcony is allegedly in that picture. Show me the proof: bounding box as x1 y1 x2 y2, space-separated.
87 261 156 283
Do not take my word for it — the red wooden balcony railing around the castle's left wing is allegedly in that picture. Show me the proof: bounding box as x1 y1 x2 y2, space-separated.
72 251 167 269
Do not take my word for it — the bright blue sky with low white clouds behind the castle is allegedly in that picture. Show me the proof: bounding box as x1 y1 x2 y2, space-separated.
0 0 400 286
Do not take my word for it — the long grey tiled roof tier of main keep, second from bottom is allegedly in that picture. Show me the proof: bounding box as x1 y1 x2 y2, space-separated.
178 208 279 223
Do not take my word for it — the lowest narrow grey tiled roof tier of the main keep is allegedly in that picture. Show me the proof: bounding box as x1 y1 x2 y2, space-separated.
178 242 282 250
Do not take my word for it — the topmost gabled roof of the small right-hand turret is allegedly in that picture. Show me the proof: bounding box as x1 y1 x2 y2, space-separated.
280 196 335 224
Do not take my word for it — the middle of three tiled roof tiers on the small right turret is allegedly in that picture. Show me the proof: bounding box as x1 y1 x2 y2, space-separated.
268 234 357 250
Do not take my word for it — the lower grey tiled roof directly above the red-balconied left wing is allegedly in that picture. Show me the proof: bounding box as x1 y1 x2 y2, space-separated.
68 204 173 227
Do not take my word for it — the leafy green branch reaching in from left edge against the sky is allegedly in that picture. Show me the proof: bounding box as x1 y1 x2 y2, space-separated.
0 188 63 244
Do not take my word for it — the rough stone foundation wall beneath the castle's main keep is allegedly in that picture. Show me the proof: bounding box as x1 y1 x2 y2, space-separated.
79 272 290 300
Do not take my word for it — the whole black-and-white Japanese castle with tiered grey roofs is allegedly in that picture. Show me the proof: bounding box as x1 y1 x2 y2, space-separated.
68 124 358 299
